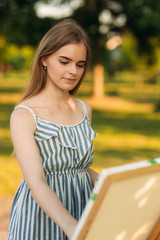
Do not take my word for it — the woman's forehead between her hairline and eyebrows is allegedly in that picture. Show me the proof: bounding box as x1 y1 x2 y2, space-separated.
54 43 87 61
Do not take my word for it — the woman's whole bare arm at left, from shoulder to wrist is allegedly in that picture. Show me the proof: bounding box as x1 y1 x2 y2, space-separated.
11 109 77 238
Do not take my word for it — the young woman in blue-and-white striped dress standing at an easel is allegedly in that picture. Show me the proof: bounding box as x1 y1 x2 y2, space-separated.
7 19 98 240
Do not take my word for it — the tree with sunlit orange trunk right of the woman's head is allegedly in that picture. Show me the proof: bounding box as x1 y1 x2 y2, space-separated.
73 0 126 98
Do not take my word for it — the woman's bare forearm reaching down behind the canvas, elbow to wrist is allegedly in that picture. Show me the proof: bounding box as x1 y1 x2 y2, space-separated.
31 180 77 238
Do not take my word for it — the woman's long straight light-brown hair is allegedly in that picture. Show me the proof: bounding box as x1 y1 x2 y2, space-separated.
22 19 90 100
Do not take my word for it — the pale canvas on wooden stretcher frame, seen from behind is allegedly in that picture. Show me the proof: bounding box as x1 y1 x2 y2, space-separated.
72 158 160 240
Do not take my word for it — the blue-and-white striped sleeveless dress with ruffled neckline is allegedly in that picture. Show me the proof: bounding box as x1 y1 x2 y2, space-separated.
7 100 97 240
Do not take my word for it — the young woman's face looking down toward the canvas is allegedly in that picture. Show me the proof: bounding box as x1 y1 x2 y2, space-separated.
42 43 87 91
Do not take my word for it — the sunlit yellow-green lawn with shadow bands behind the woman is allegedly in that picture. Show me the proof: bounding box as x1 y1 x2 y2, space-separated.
0 73 160 196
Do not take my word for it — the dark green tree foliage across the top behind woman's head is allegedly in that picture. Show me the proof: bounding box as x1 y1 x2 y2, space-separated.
0 0 160 68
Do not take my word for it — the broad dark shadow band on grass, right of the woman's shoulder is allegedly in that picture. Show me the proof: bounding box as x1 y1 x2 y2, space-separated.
92 110 160 136
